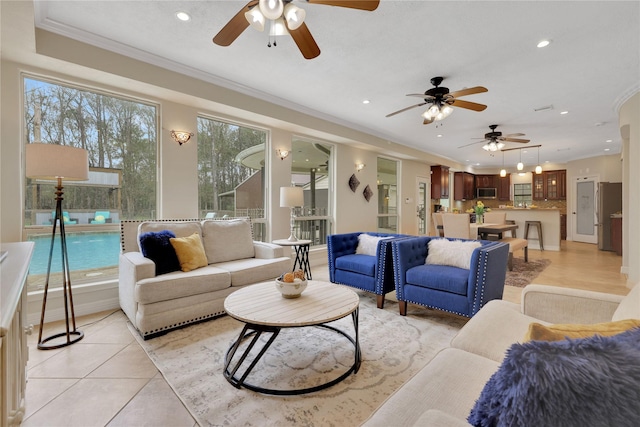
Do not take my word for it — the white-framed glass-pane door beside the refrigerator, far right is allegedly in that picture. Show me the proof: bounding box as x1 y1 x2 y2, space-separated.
572 176 598 244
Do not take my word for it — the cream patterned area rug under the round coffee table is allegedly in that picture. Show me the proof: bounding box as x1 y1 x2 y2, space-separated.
132 292 467 426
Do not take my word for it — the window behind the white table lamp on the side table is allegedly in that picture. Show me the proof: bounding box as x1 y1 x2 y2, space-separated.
291 137 331 246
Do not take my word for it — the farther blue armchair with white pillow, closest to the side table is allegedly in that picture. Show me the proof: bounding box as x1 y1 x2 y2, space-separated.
327 232 408 308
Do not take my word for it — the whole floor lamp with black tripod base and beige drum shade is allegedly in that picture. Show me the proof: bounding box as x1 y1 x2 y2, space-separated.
26 143 89 350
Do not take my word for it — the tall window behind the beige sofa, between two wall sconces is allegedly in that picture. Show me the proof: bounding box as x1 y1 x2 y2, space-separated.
198 117 267 240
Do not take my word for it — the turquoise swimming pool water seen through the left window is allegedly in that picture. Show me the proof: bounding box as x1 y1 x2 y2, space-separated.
29 232 120 274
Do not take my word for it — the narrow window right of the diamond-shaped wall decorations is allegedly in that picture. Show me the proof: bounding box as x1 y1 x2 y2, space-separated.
377 157 398 233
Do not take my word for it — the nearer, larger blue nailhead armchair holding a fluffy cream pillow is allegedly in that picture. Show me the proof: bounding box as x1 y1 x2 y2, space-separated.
392 237 509 317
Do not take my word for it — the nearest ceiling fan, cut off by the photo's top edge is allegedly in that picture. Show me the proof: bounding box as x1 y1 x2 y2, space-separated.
213 0 380 59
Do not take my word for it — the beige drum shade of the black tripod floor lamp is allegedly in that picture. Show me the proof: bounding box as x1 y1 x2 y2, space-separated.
25 143 89 181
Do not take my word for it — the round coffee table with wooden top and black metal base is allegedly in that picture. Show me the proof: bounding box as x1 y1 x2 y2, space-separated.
224 280 362 395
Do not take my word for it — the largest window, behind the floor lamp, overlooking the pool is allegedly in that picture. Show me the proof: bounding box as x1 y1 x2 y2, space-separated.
23 77 157 290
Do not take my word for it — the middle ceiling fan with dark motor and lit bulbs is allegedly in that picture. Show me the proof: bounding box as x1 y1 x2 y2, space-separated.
385 77 487 125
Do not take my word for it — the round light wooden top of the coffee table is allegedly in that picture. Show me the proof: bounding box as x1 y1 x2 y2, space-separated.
224 280 360 327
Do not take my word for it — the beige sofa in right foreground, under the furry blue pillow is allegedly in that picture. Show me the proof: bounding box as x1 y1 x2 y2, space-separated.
364 283 640 427
